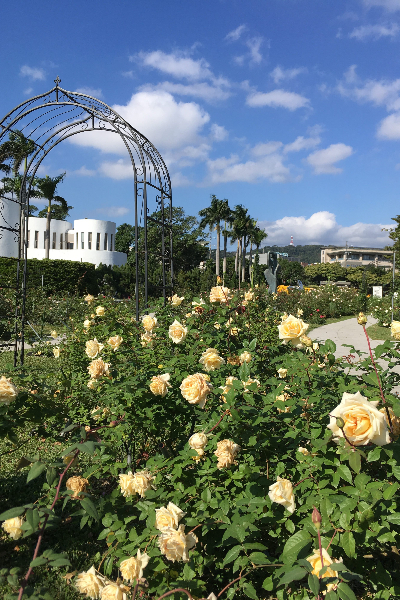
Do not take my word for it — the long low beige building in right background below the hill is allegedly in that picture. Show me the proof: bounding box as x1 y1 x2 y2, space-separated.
321 246 393 269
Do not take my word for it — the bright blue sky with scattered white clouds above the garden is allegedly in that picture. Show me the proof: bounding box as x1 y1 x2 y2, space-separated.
0 0 400 246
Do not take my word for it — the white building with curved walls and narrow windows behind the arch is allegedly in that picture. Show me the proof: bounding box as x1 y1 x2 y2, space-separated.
0 199 127 267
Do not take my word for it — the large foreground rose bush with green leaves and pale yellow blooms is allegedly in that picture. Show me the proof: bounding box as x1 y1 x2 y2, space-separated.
0 289 400 600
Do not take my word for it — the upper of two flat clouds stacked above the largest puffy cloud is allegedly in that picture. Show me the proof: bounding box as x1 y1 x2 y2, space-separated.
129 50 213 81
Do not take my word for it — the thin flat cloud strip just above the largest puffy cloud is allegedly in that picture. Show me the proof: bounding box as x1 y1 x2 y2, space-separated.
139 78 231 102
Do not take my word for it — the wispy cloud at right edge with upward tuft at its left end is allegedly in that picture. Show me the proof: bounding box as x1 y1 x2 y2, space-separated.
337 65 400 110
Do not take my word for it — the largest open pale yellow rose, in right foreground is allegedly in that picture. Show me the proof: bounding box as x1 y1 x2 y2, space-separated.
328 392 390 446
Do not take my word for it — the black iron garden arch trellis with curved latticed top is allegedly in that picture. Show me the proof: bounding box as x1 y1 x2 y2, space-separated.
0 77 174 366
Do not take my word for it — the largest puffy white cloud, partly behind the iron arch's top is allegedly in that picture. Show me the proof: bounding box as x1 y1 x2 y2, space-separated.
69 90 210 158
